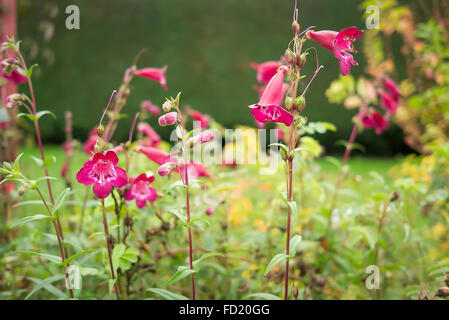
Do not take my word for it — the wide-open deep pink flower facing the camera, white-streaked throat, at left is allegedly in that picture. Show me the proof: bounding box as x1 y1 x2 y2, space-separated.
76 151 128 199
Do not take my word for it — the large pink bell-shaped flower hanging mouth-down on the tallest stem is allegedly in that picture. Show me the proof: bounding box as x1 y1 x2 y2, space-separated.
248 67 293 126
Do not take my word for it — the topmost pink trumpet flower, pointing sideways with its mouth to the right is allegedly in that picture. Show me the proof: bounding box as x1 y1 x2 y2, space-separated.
308 27 363 76
